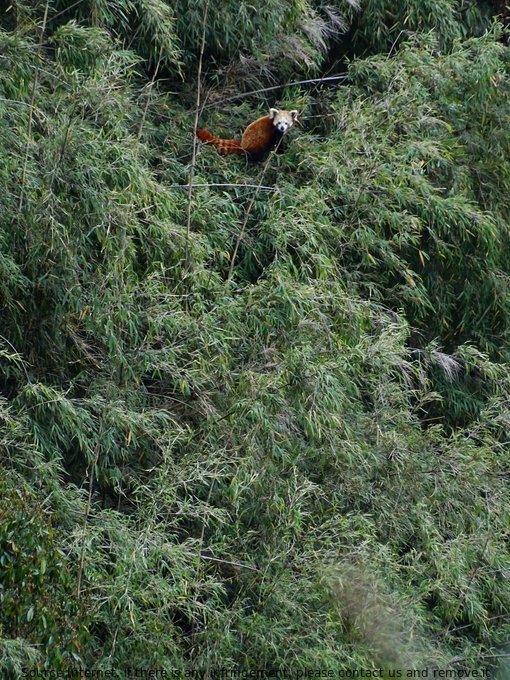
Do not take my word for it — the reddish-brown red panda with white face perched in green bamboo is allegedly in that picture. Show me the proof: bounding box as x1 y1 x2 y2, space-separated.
197 109 298 161
